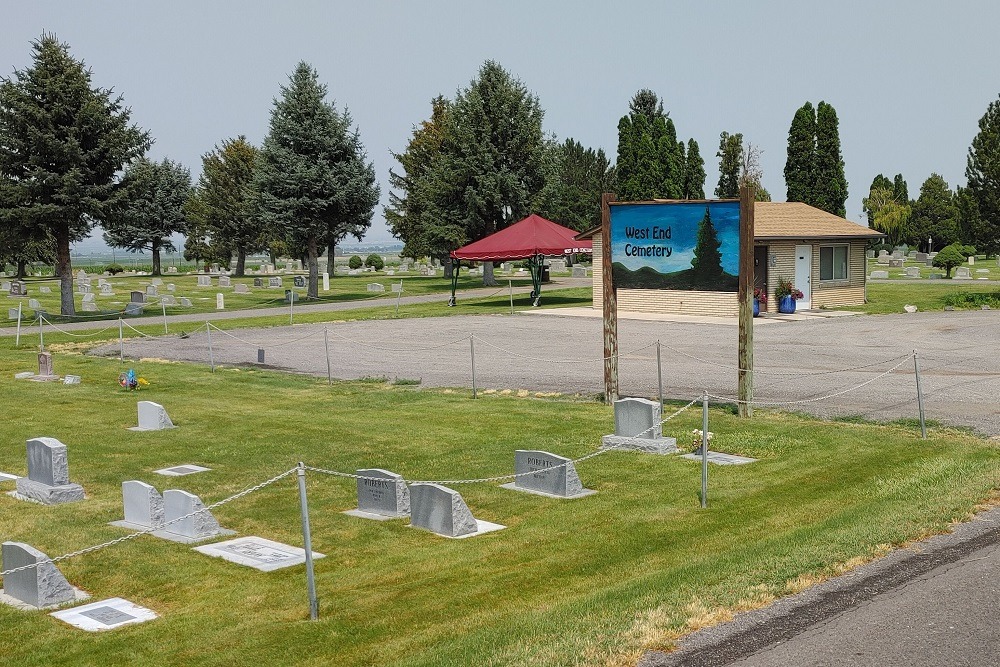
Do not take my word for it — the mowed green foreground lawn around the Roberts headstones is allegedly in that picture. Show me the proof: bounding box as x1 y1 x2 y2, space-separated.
0 342 1000 666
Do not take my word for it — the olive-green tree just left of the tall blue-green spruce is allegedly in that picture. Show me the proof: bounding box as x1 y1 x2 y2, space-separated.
192 135 266 276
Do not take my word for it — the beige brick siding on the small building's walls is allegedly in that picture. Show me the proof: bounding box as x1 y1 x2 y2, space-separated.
593 236 866 317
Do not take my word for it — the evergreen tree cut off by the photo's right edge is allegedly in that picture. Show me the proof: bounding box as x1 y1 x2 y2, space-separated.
965 95 1000 255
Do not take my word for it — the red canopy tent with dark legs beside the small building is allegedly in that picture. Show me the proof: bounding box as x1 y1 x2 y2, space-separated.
448 213 594 306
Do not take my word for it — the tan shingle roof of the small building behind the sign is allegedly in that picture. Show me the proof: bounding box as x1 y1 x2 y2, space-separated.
576 202 884 240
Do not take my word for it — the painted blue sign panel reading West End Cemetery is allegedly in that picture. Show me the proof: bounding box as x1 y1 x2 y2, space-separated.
611 201 740 292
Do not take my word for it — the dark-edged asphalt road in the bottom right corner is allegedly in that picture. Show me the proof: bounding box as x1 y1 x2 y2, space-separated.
639 510 1000 667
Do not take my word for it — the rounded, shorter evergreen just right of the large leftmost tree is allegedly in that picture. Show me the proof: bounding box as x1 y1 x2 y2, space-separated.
101 158 191 276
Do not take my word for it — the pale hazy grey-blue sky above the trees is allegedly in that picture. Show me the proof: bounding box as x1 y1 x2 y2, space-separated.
0 0 1000 241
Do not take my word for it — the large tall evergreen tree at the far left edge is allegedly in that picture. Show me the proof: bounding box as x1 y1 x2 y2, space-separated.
0 34 151 315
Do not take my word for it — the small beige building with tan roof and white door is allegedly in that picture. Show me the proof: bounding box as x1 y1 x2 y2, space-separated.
577 202 885 317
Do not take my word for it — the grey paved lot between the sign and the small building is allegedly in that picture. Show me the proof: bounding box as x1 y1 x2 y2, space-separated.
90 310 1000 435
